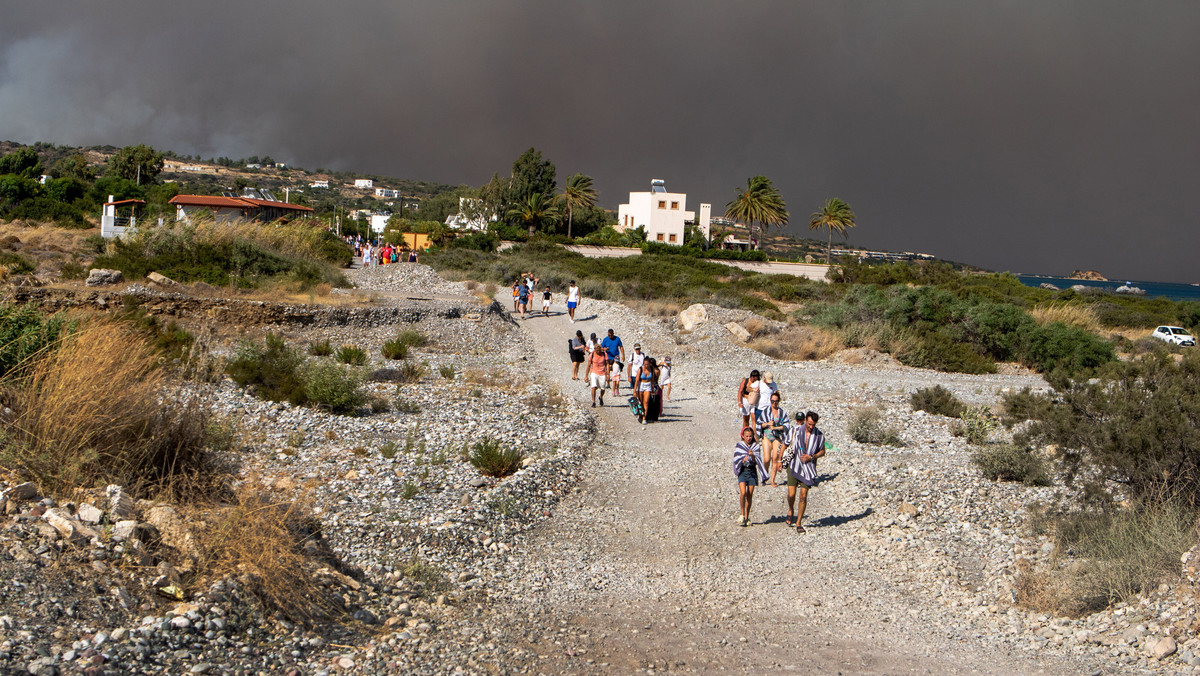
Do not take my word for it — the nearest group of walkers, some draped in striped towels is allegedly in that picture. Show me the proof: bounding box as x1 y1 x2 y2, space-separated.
733 369 832 533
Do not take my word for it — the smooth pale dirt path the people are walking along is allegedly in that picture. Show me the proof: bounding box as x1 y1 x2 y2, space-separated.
499 298 1094 674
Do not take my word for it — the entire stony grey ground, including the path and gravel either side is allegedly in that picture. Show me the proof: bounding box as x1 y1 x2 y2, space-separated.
0 264 1200 674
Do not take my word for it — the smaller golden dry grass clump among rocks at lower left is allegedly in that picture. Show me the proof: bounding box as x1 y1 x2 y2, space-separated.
197 480 342 624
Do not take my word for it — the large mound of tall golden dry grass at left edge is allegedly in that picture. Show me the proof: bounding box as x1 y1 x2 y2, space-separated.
0 322 223 492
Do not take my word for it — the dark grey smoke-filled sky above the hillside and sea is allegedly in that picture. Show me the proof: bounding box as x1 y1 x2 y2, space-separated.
0 0 1200 282
